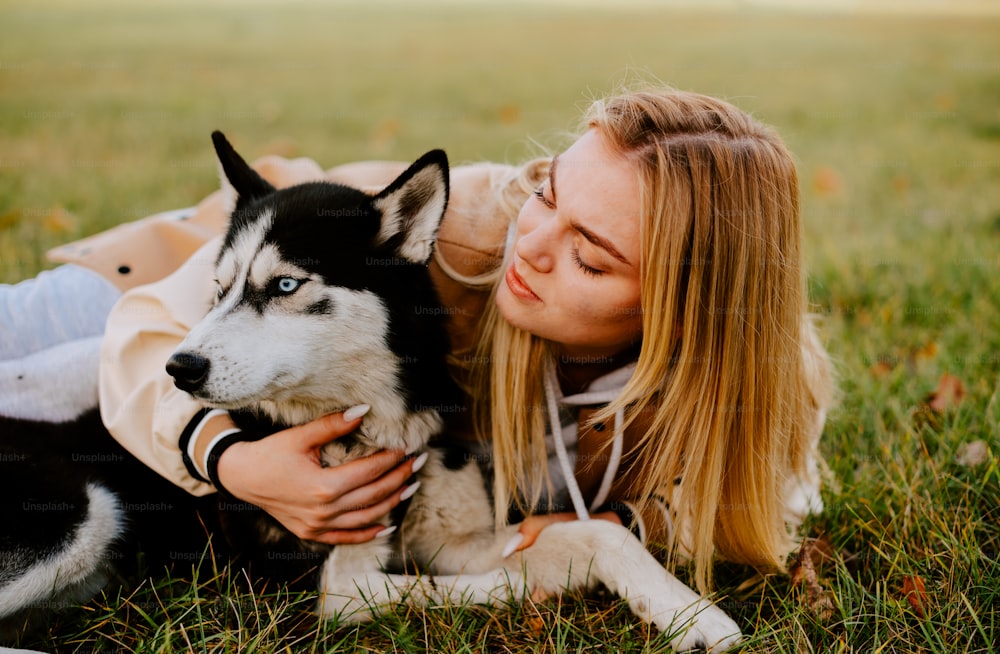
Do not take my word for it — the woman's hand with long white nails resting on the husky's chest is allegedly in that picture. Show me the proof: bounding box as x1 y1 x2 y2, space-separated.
218 409 426 545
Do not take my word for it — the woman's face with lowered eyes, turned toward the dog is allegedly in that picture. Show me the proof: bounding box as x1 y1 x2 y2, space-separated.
497 129 642 363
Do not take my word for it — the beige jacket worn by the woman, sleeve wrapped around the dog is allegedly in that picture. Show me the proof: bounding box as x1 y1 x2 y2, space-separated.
50 157 836 552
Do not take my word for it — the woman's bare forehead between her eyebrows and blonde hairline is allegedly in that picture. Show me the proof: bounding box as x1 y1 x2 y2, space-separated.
552 129 641 261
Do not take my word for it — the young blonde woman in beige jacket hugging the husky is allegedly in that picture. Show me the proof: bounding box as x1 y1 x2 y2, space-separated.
0 89 832 591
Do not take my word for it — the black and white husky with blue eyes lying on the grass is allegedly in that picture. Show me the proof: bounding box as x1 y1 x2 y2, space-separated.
0 132 739 650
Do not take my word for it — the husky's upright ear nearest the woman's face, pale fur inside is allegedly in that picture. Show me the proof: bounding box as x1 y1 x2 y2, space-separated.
373 150 448 264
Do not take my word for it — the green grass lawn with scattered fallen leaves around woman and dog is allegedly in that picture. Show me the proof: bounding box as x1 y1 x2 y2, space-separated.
0 1 1000 652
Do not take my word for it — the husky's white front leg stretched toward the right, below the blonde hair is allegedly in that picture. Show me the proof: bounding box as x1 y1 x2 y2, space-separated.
507 520 740 651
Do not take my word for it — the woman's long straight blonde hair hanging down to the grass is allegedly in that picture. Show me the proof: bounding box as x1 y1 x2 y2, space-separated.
473 89 832 591
